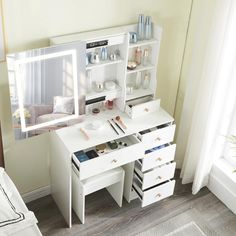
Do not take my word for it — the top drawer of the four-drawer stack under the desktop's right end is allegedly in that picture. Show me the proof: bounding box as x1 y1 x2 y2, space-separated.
138 123 176 149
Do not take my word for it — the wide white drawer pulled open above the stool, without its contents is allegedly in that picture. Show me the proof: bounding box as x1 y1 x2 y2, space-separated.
72 135 144 180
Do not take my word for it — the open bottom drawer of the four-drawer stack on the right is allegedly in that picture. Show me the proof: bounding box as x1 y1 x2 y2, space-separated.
133 180 175 207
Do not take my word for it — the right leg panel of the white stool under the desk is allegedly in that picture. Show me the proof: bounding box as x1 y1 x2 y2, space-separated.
107 171 125 207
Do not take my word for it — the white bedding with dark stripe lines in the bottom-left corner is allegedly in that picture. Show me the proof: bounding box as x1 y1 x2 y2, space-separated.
0 168 41 236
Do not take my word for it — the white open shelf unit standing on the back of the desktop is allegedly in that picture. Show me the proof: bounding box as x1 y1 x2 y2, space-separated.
50 24 161 111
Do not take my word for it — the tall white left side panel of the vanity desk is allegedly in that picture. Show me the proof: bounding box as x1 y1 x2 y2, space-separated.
50 132 71 227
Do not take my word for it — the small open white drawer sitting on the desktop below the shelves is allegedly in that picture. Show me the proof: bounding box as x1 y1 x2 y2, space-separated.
125 99 160 119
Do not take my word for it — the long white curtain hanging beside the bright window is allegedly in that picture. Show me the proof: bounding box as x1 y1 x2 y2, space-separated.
176 0 236 194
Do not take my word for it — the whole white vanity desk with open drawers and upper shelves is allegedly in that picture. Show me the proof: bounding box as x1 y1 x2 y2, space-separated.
50 24 175 227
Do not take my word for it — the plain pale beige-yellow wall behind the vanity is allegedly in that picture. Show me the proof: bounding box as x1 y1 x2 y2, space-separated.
0 0 191 193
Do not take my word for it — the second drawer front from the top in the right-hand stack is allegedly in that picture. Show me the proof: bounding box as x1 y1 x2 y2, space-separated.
141 144 176 171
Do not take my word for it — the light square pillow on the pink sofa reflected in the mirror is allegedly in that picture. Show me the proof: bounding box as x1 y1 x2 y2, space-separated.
53 96 74 115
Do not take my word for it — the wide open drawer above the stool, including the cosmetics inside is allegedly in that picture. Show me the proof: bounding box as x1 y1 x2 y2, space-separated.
72 135 144 180
